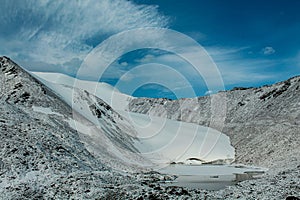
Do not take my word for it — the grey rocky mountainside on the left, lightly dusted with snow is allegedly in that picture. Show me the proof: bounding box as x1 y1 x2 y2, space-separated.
0 57 147 199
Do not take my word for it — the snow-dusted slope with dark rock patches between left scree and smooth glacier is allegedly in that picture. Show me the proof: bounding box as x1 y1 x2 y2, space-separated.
33 75 148 170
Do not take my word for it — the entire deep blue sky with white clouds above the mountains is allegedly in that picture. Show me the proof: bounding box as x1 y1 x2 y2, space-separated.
0 0 300 99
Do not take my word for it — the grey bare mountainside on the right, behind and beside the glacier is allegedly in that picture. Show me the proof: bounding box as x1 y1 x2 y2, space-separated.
129 76 300 171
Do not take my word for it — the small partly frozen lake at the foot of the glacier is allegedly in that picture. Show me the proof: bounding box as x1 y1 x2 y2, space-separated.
159 164 267 190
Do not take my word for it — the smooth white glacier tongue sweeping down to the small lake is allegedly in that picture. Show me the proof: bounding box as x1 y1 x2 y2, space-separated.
33 72 235 167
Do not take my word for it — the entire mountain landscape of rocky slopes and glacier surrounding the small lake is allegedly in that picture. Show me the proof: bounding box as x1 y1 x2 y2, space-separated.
0 57 300 199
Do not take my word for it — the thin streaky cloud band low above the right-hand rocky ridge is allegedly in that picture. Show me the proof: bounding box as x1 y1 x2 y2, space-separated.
98 39 286 97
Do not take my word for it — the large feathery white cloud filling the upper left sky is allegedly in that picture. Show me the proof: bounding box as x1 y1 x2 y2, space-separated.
0 0 168 72
